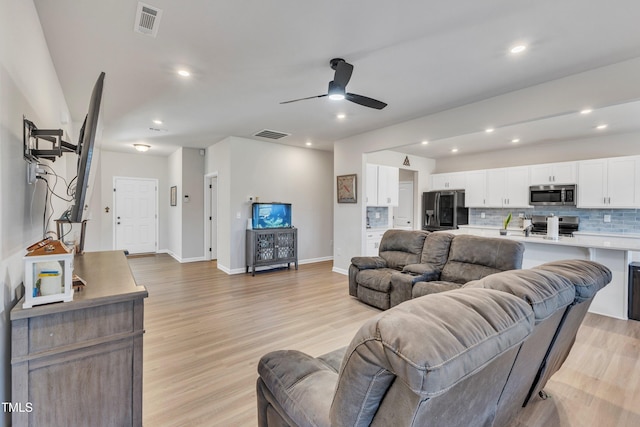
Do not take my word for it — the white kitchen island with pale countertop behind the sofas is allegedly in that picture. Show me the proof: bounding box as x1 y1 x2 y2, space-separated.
453 225 640 319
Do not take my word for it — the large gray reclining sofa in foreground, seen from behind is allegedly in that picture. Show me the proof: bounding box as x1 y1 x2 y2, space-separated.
257 260 611 427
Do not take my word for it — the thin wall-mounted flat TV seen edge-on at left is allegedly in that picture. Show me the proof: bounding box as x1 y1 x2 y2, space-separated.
68 72 104 222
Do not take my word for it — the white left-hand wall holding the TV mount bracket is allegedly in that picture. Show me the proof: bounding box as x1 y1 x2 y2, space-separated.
0 0 72 425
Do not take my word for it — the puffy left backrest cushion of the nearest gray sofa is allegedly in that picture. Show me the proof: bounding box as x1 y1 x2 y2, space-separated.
331 289 533 425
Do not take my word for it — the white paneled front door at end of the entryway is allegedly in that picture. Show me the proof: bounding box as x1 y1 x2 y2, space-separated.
113 178 158 254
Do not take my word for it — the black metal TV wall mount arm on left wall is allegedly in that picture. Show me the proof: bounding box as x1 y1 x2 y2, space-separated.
22 116 78 162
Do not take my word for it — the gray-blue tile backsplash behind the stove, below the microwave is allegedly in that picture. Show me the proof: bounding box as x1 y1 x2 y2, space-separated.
469 207 640 235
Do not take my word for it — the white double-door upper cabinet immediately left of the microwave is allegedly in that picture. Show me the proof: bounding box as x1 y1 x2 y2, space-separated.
486 166 529 208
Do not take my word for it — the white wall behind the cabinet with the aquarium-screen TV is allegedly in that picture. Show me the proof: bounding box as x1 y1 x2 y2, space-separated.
206 137 335 273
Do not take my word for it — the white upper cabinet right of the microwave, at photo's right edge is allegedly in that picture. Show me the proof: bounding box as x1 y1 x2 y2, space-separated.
578 156 640 208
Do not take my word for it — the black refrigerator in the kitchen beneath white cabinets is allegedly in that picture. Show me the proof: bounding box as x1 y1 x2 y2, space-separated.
422 190 469 231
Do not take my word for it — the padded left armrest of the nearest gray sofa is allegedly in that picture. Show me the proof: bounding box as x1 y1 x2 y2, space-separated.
258 350 338 426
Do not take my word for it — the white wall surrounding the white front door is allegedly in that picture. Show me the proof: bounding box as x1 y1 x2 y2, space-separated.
90 150 169 252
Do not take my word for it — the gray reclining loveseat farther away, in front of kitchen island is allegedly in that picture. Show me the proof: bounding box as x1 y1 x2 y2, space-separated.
349 230 524 310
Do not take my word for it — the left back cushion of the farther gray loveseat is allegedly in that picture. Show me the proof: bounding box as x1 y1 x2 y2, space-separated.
379 230 428 270
